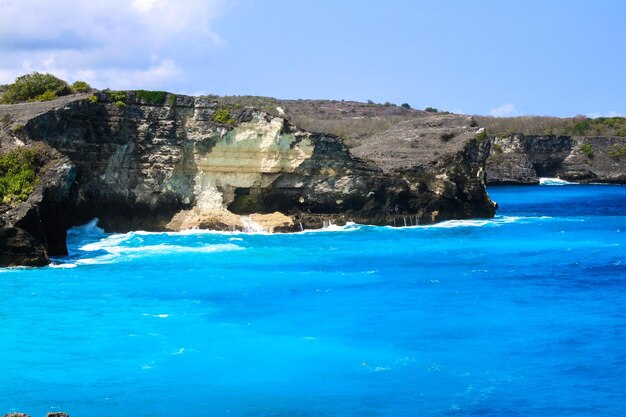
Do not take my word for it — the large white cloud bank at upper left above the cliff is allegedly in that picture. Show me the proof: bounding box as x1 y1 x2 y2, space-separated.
0 0 226 89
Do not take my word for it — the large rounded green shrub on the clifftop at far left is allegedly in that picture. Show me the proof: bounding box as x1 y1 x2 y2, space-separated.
0 72 72 104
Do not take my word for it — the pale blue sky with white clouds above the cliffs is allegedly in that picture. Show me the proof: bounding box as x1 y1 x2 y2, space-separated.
0 0 626 117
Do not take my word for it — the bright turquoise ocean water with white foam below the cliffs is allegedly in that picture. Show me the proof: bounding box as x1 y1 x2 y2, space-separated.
0 181 626 417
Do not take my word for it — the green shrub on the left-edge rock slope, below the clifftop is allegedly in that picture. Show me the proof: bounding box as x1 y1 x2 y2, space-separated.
0 148 44 204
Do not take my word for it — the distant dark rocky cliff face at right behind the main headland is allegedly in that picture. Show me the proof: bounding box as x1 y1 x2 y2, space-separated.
486 135 626 184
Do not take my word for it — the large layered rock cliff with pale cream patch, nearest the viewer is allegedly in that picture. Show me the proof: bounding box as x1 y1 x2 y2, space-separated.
0 91 495 265
